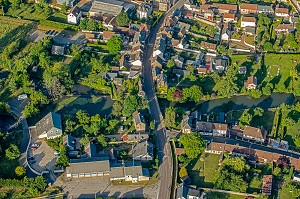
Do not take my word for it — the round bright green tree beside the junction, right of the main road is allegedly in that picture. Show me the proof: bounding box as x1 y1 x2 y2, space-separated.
179 133 205 159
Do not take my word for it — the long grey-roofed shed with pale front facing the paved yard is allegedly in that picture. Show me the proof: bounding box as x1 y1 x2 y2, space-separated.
66 158 110 178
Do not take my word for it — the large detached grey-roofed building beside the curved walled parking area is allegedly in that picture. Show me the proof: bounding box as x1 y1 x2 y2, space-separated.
31 112 62 139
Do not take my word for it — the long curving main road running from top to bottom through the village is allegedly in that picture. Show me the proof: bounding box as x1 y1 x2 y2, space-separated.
143 0 184 199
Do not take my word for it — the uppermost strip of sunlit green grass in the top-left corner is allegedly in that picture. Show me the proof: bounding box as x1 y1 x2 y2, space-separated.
6 3 47 21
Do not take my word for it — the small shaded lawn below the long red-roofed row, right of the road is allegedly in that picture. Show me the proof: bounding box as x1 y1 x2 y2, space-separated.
187 153 220 188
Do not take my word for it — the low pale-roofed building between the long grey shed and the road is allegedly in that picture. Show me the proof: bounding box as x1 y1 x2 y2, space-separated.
110 165 150 183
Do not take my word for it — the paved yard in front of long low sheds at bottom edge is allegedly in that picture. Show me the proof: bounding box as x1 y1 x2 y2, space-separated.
64 176 158 199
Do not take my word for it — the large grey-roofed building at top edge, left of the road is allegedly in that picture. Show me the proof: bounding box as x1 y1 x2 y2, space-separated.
89 0 135 17
